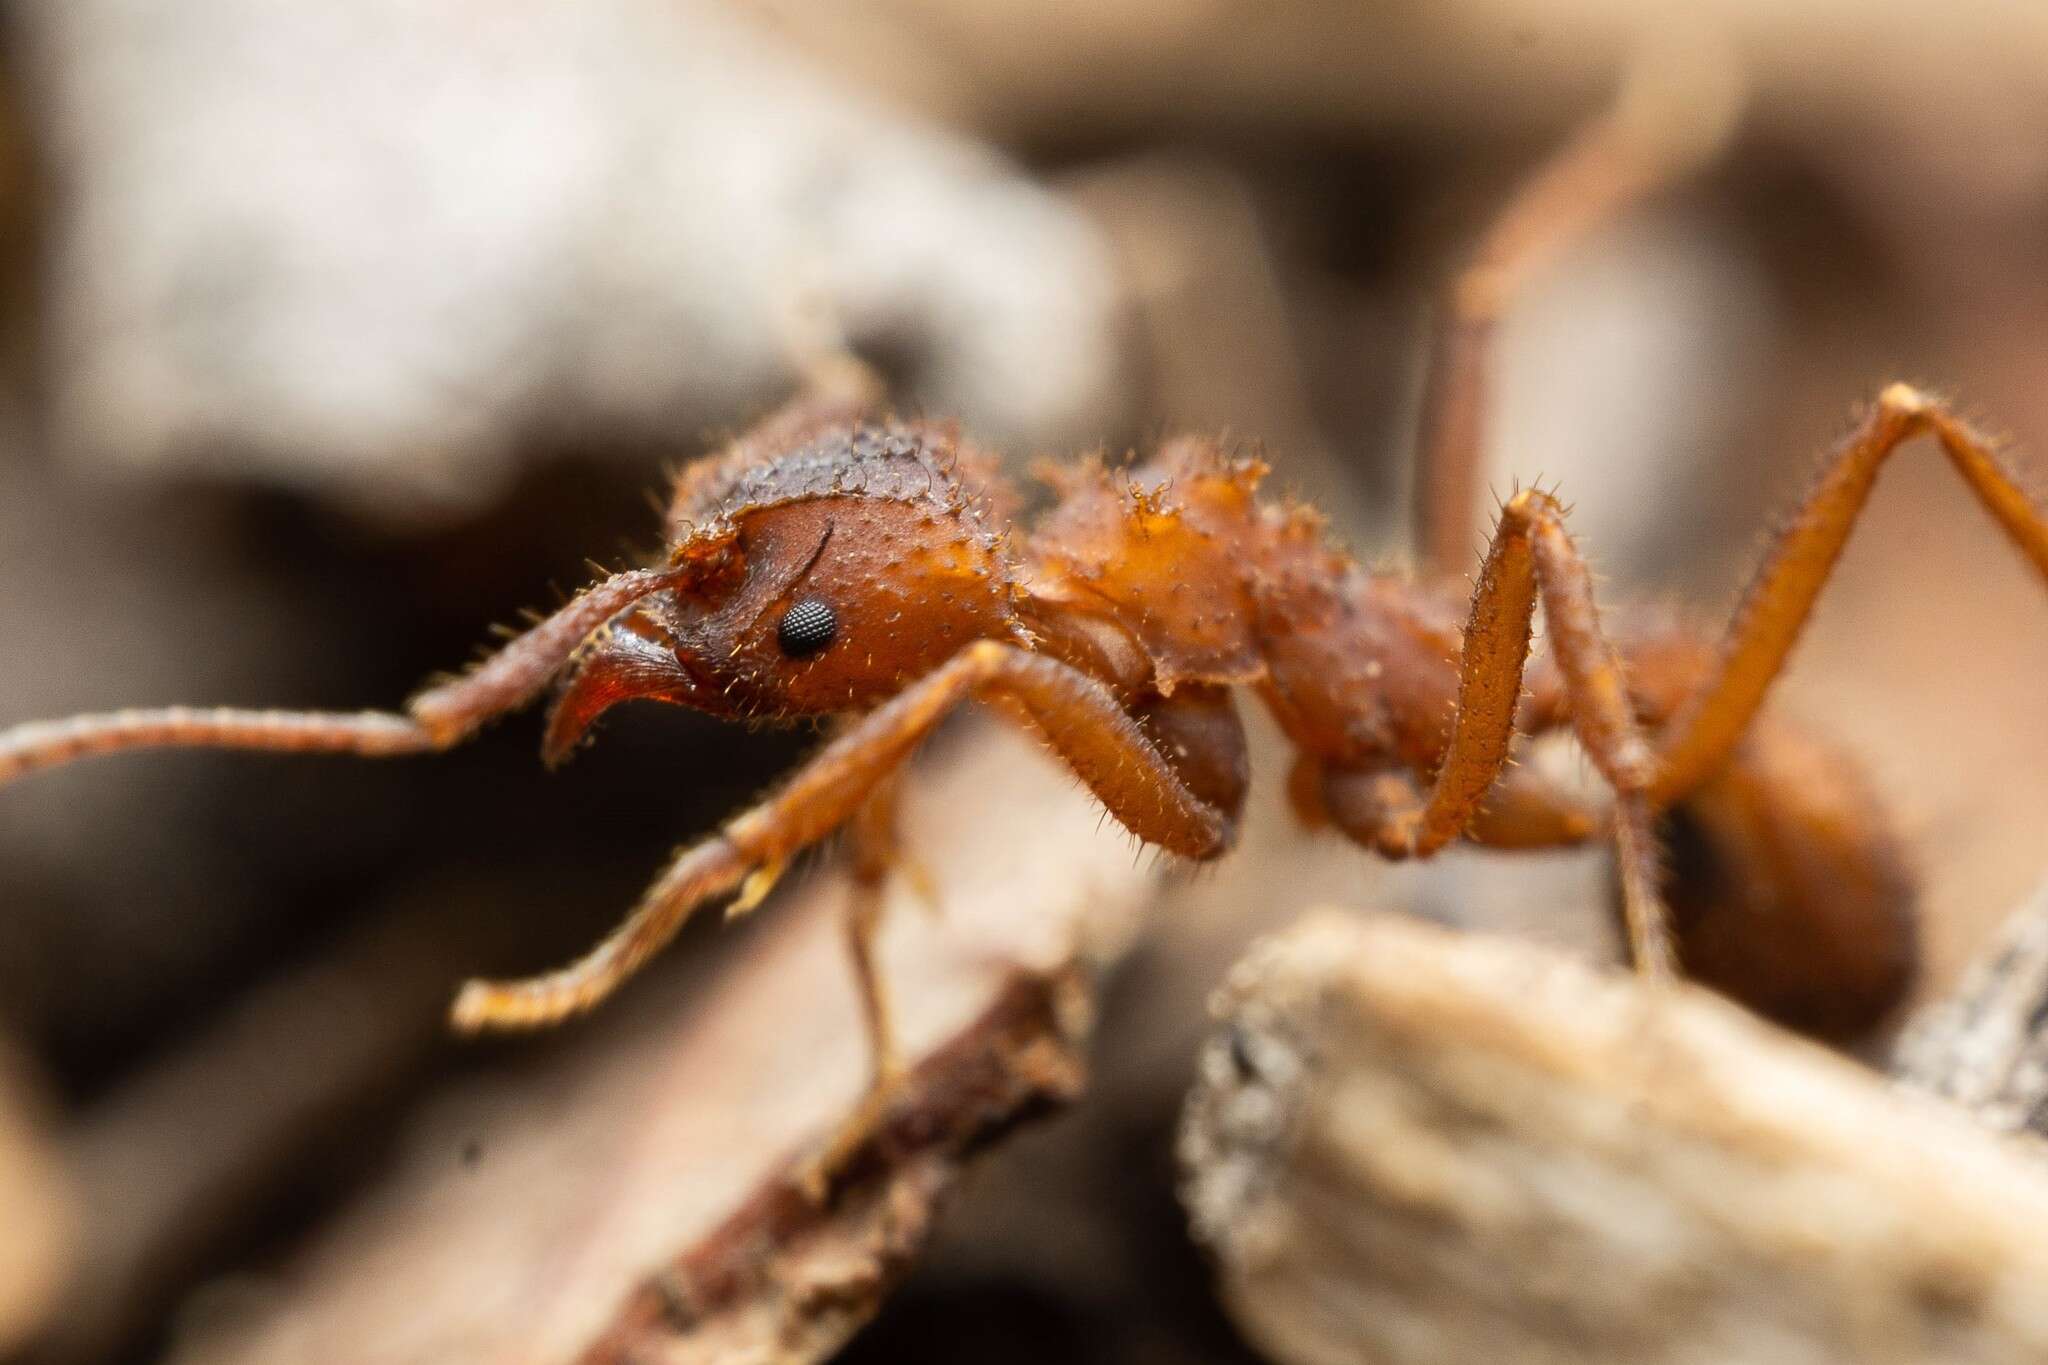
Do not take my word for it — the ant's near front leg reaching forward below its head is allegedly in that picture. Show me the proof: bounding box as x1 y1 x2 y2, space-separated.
455 641 1231 1031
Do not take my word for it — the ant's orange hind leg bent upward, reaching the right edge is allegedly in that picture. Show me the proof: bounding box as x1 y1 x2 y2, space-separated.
1651 385 2048 806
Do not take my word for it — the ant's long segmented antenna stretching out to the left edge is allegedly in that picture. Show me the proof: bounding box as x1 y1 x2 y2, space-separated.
0 569 676 786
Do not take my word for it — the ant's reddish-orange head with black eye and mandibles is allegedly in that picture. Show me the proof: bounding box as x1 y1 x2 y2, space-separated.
547 422 1026 759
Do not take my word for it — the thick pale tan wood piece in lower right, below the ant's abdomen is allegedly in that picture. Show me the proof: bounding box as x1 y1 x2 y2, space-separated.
1182 913 2048 1365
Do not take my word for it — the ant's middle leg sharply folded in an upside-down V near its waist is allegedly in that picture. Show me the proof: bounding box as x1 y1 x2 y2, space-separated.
1359 489 1671 974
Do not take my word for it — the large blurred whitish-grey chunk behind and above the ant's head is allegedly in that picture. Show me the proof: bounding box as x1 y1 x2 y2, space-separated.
23 0 1114 518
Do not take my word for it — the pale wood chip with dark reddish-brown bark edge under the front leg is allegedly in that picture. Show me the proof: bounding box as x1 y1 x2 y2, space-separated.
159 737 1151 1365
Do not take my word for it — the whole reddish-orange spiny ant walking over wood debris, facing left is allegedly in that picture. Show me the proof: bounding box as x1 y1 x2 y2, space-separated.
0 69 2048 1170
